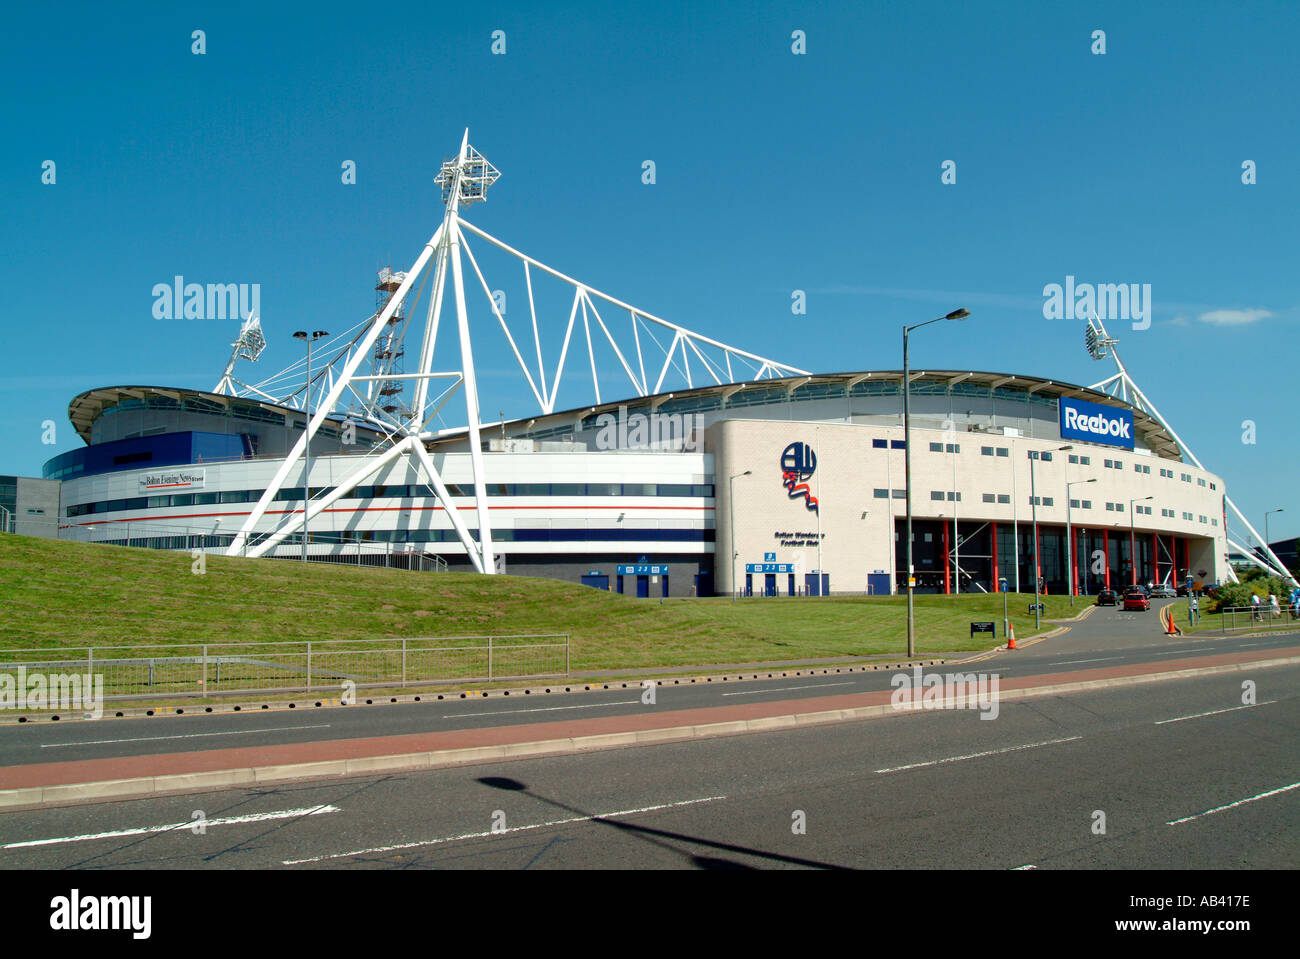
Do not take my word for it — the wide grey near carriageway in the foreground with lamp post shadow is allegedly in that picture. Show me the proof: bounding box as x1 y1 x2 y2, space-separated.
0 667 1300 869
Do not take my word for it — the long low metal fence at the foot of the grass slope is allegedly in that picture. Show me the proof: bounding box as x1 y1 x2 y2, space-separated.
0 633 569 700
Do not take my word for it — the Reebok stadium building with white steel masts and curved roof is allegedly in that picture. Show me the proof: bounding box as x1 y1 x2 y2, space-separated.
44 134 1281 596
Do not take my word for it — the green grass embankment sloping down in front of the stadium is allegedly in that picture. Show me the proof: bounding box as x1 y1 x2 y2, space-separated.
0 535 1087 674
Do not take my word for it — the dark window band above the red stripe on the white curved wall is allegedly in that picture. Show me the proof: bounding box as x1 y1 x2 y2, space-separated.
68 483 714 518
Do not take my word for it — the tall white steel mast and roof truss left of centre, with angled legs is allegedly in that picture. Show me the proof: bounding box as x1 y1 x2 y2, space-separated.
228 130 807 573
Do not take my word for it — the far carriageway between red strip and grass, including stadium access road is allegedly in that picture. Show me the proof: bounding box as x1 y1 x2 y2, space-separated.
0 607 1300 767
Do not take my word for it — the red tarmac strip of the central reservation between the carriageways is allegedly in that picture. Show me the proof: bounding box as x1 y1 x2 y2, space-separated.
0 646 1300 789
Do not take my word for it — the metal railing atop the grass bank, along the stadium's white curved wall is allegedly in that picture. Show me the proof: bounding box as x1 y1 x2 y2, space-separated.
59 521 447 573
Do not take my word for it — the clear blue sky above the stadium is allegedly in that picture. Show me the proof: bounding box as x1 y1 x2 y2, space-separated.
0 3 1300 539
